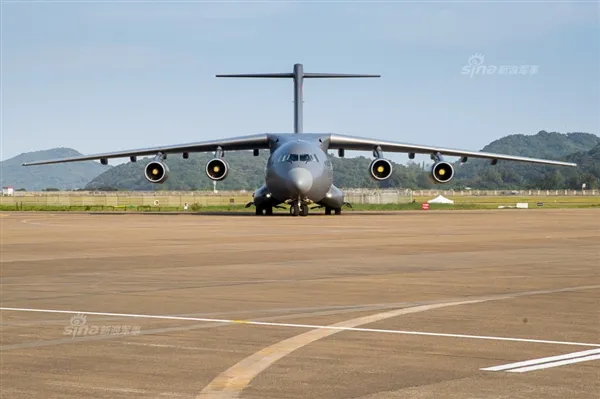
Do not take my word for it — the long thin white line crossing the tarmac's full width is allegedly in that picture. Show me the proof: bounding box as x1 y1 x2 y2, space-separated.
0 307 600 348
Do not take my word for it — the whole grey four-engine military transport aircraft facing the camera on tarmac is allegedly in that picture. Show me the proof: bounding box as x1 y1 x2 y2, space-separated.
23 64 577 216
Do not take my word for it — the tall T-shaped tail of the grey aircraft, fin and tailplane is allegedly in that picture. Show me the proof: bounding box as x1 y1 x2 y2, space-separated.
215 64 381 133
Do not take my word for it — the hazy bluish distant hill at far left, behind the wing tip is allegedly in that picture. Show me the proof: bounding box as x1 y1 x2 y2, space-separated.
0 148 111 191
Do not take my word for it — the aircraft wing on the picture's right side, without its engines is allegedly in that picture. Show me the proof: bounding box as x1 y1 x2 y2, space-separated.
329 134 577 166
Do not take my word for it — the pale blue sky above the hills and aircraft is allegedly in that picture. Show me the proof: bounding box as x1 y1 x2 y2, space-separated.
1 1 600 161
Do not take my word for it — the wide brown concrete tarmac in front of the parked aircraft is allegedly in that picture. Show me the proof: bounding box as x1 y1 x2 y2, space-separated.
0 209 600 399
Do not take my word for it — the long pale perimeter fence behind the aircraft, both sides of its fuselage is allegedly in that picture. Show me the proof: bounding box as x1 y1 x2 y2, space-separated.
0 190 413 207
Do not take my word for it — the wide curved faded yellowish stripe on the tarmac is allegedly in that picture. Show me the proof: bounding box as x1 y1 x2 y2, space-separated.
196 299 487 399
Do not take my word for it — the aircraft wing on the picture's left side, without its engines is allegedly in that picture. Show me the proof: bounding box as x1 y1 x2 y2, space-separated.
23 133 269 166
